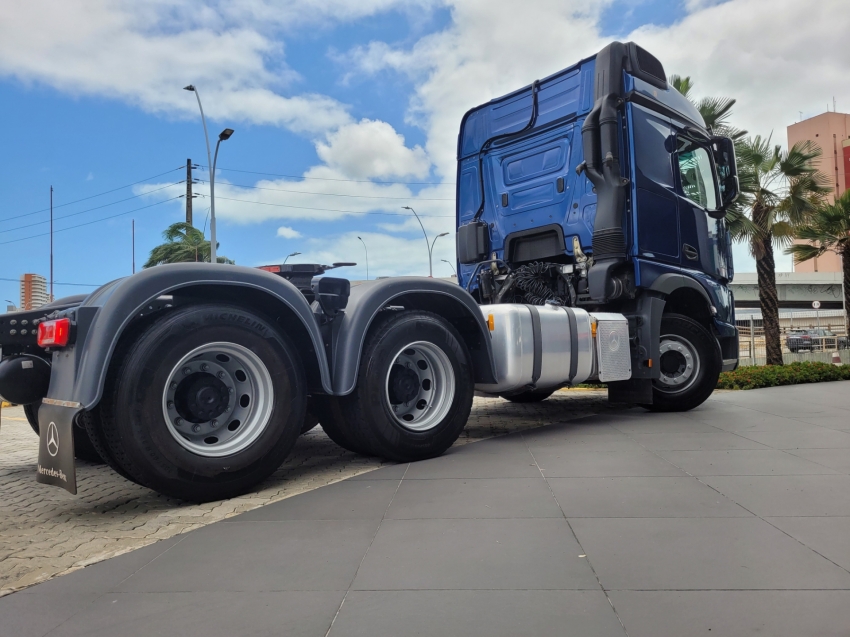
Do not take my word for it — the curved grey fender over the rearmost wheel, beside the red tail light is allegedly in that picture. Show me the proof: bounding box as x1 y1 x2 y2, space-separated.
47 263 331 409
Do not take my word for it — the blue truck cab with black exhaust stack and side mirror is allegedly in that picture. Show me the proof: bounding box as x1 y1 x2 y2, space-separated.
456 42 739 403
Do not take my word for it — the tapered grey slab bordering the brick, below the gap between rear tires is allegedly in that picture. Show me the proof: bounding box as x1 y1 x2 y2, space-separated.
237 474 399 522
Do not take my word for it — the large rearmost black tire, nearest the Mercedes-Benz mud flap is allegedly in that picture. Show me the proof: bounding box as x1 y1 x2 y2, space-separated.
100 304 307 502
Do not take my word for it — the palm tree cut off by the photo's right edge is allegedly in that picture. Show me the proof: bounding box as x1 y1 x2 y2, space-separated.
785 190 850 334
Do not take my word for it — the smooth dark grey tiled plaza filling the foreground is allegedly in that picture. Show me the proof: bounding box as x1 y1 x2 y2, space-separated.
0 383 850 637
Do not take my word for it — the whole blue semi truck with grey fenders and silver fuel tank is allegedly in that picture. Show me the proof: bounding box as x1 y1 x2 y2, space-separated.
0 42 739 501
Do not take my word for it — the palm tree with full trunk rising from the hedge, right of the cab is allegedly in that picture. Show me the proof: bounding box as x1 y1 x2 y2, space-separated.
736 135 829 365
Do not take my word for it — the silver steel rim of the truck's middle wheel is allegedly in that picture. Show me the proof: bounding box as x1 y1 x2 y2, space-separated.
384 341 455 431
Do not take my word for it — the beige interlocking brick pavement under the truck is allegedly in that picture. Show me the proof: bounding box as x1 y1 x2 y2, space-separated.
0 390 618 596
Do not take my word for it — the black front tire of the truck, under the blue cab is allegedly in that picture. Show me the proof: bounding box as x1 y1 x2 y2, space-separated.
643 314 723 411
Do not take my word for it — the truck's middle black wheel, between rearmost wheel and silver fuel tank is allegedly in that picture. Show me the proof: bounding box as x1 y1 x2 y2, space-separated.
323 310 474 462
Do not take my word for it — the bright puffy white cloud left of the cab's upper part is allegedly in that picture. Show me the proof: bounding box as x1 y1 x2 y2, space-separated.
316 119 431 179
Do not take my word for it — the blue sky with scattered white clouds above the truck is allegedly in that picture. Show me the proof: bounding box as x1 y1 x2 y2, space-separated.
0 0 850 303
